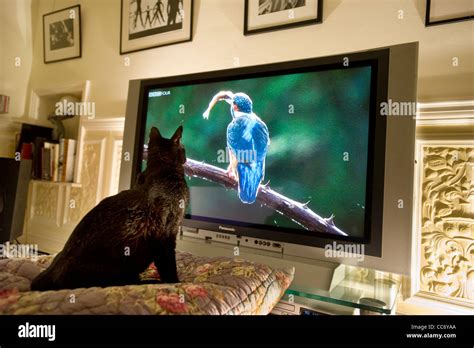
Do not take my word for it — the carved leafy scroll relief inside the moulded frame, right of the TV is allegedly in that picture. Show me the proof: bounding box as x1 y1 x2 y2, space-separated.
419 144 474 305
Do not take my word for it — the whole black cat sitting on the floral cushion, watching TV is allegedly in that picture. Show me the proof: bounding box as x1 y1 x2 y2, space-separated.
31 127 189 290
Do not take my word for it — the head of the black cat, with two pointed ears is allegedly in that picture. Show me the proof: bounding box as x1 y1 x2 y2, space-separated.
147 126 186 168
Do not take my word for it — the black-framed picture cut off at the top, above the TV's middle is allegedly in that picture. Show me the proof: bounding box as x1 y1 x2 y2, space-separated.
244 0 323 35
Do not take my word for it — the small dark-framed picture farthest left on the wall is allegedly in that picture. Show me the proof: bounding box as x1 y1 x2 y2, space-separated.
43 5 82 63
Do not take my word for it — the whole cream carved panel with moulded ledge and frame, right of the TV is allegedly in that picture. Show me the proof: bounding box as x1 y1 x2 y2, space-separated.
397 100 474 315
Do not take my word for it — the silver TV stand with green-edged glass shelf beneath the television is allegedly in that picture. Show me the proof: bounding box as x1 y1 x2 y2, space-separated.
177 233 401 315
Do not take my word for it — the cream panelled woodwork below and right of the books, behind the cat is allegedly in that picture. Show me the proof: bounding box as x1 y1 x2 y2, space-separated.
24 117 125 253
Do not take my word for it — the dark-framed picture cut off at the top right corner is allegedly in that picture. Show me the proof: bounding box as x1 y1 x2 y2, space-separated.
425 0 474 27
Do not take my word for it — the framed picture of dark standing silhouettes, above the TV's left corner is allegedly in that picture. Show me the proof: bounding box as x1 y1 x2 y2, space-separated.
120 0 193 54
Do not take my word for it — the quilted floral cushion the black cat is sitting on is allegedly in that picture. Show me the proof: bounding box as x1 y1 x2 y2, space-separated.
0 252 294 314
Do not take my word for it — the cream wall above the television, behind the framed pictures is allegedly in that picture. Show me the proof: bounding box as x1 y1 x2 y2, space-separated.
24 0 474 122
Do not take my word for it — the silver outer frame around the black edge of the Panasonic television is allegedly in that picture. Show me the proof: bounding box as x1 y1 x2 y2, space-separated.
119 42 418 275
